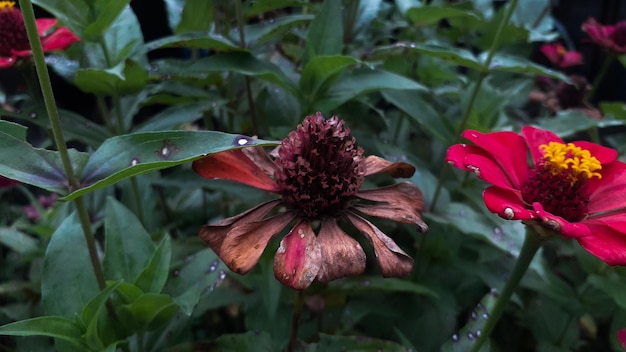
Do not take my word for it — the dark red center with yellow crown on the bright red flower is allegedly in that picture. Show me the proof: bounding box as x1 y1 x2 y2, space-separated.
521 142 602 222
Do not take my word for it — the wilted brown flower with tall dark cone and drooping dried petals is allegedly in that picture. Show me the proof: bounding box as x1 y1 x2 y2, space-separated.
193 113 427 289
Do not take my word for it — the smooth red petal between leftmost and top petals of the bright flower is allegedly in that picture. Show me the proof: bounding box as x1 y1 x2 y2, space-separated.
463 130 528 189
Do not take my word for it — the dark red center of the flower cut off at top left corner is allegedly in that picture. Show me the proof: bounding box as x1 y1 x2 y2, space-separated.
0 1 30 57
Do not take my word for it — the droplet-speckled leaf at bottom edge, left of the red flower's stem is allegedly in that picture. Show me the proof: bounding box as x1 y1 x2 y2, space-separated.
441 290 498 352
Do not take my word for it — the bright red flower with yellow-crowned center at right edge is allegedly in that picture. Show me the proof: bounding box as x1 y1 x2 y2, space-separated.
446 126 626 265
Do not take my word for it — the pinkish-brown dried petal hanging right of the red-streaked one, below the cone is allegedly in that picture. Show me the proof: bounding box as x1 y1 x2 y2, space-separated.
317 218 366 283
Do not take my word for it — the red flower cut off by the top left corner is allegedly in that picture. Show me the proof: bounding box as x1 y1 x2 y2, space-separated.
0 1 80 68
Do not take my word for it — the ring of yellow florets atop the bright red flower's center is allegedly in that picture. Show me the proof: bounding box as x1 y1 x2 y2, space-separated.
539 142 602 182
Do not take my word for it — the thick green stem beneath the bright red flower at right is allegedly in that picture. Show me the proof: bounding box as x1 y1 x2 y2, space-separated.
472 226 545 352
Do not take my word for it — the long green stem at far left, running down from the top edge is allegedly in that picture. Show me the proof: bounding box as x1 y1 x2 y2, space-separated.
20 0 106 289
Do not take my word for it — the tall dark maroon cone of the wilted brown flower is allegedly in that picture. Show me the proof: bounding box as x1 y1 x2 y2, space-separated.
274 113 364 219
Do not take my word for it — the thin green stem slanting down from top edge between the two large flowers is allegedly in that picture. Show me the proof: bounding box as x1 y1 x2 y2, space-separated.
430 0 518 211
